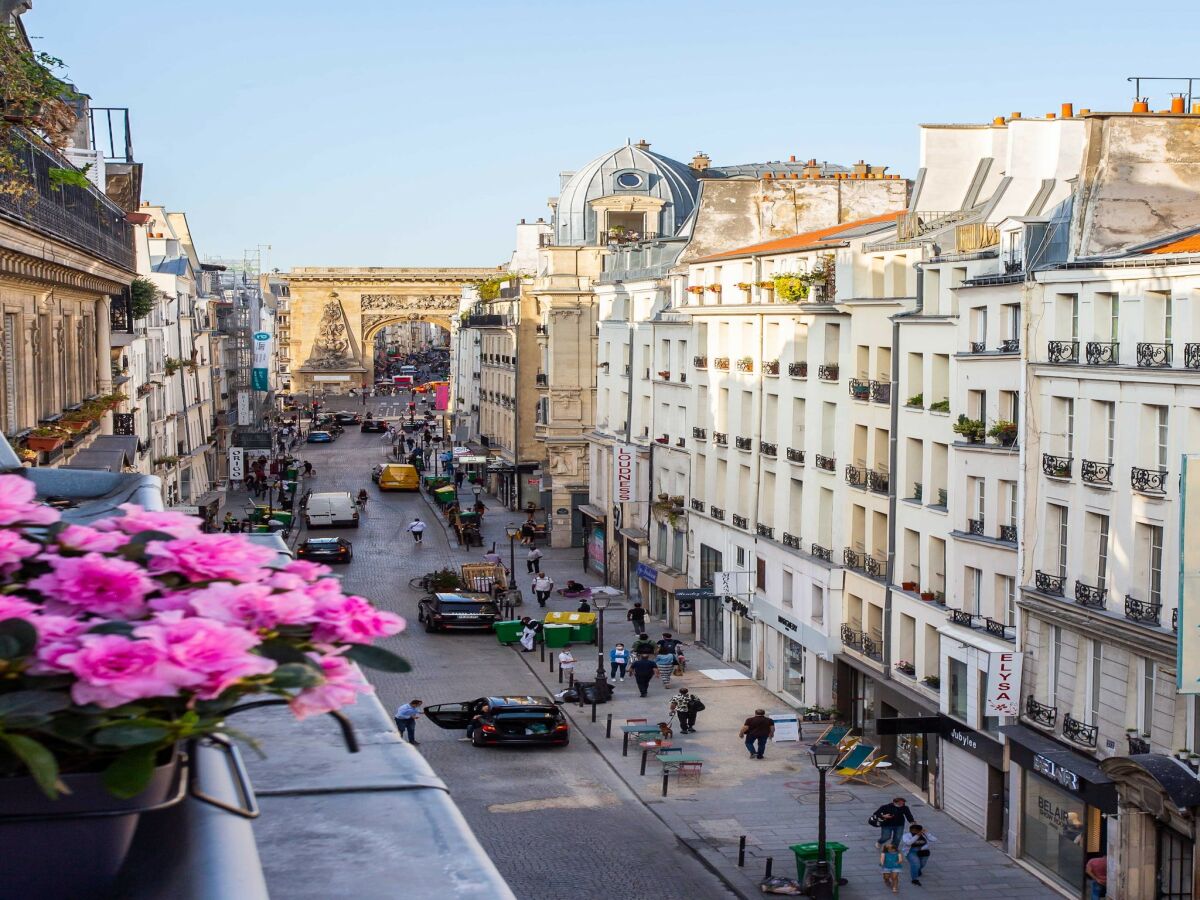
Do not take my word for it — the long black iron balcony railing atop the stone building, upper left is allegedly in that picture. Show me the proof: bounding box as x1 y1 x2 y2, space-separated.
0 127 134 271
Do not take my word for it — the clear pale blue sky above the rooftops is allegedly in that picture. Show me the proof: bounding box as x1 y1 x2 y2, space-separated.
24 0 1200 269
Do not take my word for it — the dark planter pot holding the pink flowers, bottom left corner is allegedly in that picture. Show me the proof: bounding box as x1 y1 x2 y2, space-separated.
0 754 186 900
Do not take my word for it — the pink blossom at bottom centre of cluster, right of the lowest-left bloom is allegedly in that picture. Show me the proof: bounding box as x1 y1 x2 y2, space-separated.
133 611 276 700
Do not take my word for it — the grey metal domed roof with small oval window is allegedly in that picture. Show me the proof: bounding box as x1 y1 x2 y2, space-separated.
554 143 700 245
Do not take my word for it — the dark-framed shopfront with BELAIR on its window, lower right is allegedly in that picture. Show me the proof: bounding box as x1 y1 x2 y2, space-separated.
1001 725 1117 896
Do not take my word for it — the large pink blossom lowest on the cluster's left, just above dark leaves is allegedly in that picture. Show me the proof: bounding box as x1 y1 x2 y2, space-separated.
56 635 204 709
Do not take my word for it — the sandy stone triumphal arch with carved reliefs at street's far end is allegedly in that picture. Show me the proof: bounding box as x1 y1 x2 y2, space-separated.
280 266 500 394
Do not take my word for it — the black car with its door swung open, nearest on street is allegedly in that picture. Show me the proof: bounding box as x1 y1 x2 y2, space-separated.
425 696 571 746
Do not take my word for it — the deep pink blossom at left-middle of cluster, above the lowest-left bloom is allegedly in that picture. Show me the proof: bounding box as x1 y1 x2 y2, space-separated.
29 553 158 618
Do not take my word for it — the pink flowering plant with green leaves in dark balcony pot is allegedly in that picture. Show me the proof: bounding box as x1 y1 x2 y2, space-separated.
0 475 408 896
